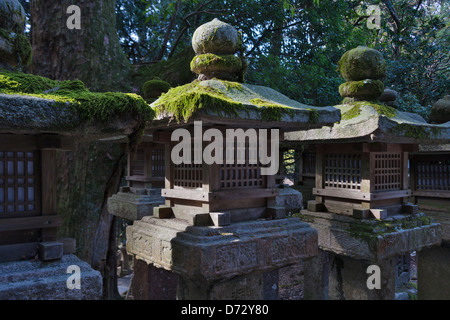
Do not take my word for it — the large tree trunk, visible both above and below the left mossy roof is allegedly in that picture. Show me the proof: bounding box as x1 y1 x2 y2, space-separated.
30 0 131 299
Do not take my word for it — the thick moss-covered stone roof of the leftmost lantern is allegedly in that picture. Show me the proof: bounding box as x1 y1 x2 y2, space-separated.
0 69 155 139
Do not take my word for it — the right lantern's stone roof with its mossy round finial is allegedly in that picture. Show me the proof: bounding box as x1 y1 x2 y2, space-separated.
285 47 450 144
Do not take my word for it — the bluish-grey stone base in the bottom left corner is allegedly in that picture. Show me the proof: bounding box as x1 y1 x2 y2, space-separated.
0 254 102 300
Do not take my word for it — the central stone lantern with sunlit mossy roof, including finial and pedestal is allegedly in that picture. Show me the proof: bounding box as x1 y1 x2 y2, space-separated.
120 19 339 299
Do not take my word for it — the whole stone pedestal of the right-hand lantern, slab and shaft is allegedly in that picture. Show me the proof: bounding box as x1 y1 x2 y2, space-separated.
301 210 441 300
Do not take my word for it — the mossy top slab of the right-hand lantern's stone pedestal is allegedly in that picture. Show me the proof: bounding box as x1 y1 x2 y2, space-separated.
301 210 441 261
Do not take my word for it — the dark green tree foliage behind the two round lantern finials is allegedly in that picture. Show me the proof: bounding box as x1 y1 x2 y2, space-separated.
117 0 450 118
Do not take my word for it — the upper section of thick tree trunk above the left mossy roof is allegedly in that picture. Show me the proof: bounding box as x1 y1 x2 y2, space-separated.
30 0 131 91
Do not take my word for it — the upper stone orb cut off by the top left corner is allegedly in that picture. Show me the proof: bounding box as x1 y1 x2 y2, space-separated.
0 0 26 34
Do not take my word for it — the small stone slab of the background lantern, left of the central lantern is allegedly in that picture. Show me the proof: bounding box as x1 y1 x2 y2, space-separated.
108 191 164 220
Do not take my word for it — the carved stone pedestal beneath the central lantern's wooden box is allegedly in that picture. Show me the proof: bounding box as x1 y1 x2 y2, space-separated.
127 216 317 300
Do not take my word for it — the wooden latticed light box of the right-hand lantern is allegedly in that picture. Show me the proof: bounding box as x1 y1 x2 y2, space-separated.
311 143 413 216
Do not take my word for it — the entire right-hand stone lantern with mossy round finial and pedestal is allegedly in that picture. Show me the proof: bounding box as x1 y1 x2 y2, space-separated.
285 47 450 299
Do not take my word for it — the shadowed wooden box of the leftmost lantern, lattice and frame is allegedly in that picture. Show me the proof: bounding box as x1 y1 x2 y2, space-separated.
0 134 65 261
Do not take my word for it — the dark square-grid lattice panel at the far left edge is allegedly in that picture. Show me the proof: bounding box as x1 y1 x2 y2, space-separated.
0 151 40 217
